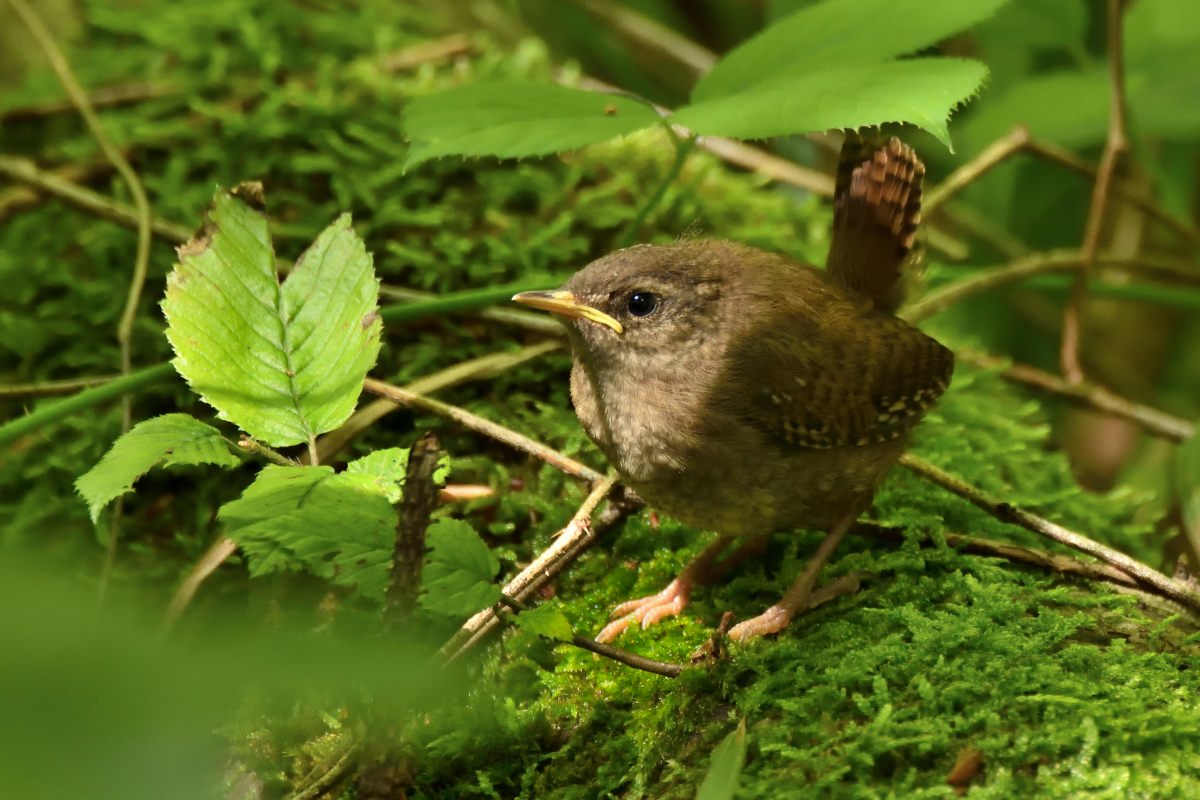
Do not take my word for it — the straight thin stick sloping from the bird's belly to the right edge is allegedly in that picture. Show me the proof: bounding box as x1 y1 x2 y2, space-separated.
900 453 1200 610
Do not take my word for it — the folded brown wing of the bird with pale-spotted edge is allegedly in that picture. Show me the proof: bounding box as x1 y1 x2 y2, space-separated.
736 305 954 449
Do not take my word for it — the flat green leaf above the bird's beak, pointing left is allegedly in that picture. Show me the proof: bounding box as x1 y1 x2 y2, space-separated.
404 80 659 169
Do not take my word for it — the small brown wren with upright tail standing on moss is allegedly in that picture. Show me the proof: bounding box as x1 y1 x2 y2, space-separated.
514 137 954 640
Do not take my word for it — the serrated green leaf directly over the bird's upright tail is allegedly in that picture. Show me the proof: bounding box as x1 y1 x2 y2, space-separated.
671 59 988 148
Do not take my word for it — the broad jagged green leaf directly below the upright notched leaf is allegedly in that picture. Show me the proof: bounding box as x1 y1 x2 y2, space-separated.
217 464 396 600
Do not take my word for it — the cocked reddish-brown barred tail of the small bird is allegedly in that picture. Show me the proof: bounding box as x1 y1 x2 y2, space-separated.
826 133 925 312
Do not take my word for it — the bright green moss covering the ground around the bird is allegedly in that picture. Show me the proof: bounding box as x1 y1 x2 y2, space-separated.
0 0 1200 798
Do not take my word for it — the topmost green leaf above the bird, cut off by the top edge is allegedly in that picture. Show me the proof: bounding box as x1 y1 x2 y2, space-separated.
691 0 1006 101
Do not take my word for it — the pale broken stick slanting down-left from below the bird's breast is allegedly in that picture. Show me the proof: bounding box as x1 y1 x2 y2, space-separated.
442 477 641 661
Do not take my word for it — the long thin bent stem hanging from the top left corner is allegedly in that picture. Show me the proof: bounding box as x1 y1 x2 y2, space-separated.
8 0 150 601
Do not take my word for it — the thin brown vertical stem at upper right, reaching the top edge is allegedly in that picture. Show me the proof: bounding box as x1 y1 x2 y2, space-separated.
1060 0 1129 383
